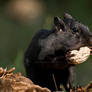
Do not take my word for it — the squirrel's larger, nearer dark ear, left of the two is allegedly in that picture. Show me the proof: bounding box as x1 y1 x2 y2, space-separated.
54 17 65 31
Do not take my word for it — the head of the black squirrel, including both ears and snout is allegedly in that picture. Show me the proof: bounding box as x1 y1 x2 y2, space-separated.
54 13 92 49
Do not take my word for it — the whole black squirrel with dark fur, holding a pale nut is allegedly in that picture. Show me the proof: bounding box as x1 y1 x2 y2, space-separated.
24 13 92 91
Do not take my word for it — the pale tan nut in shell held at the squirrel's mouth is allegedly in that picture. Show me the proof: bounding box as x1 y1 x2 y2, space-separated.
66 47 91 65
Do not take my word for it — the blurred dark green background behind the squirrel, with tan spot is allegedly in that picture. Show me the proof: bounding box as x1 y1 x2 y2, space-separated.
0 0 92 85
